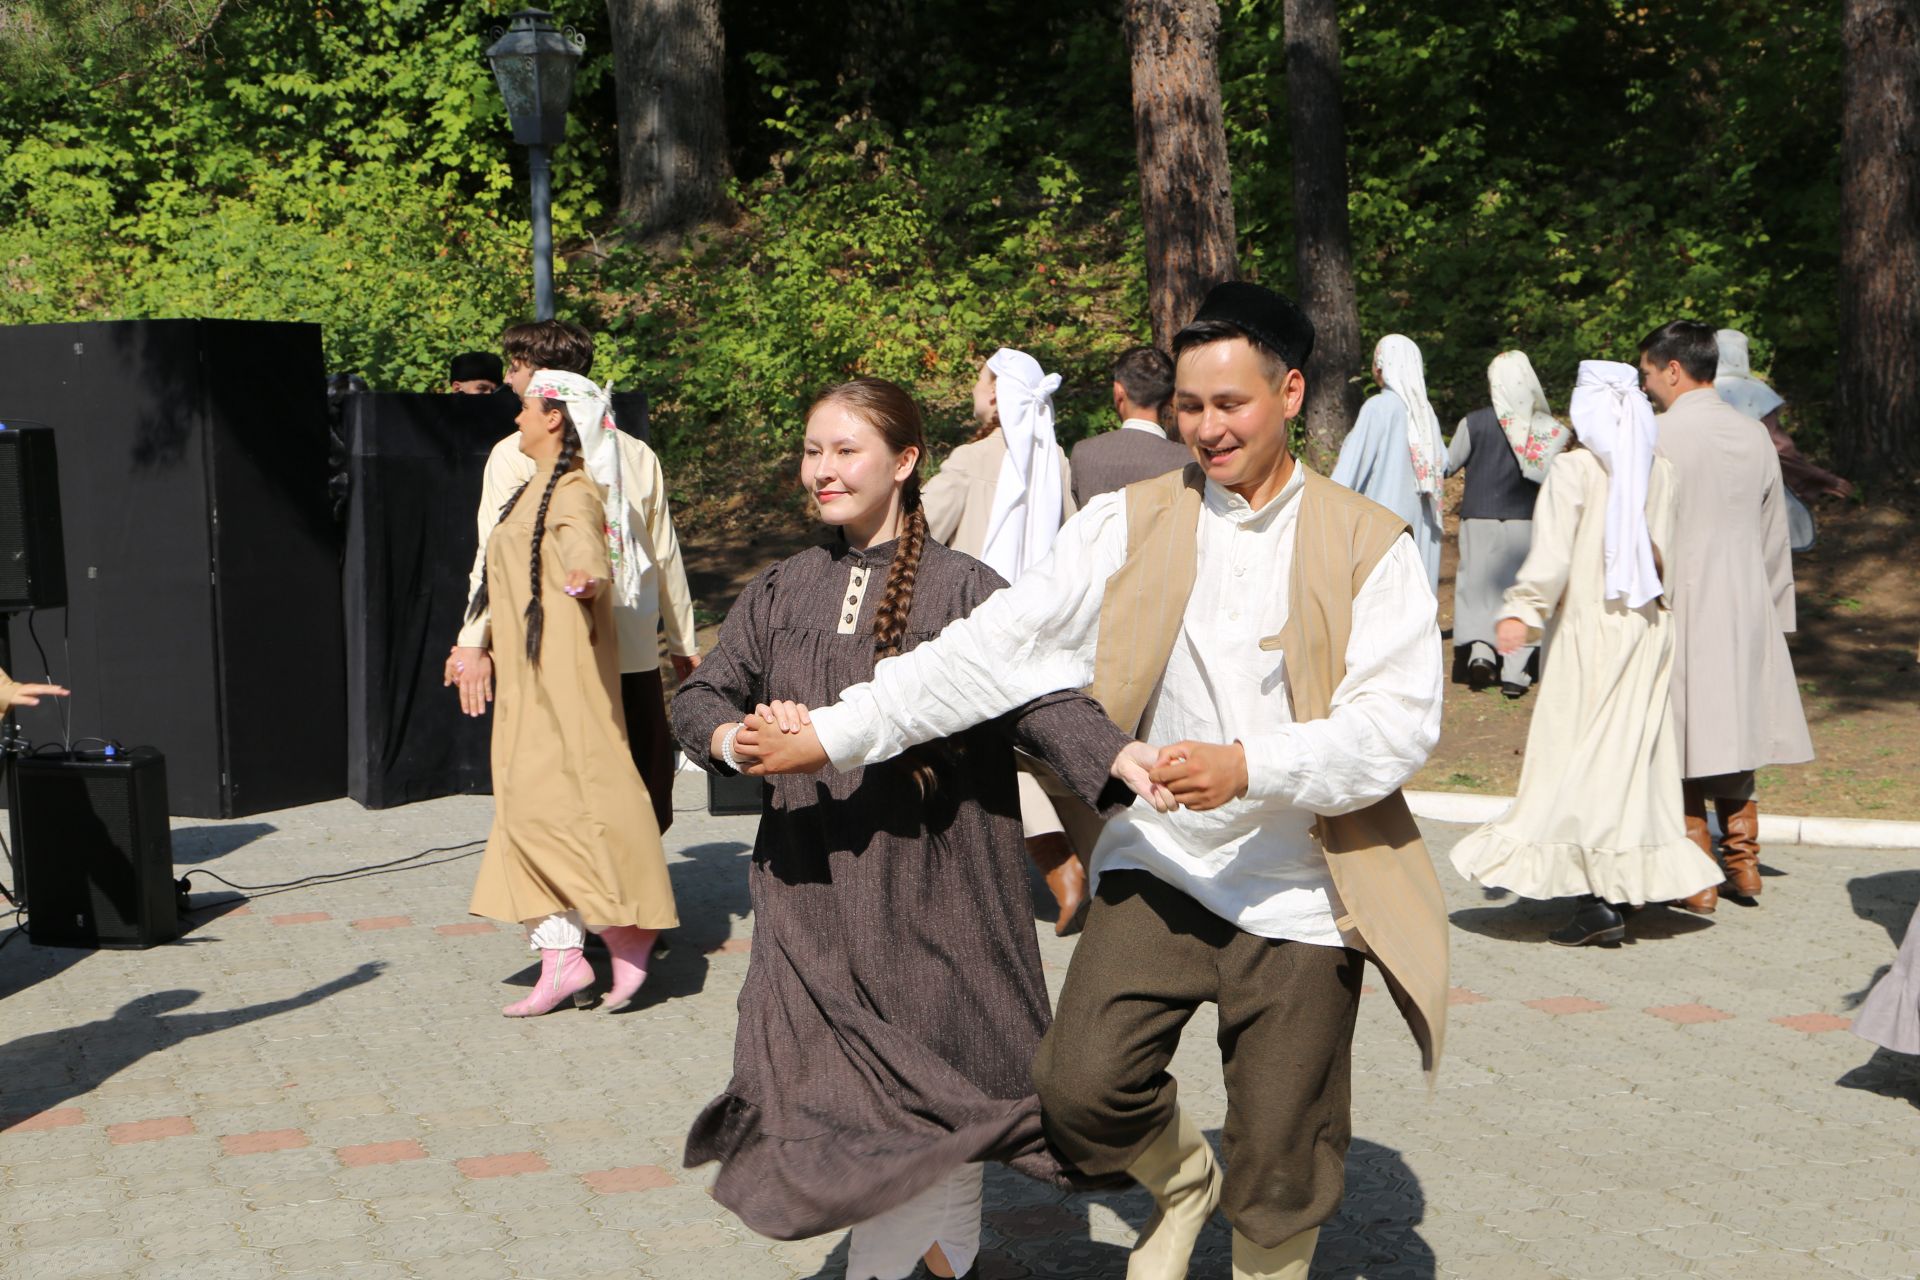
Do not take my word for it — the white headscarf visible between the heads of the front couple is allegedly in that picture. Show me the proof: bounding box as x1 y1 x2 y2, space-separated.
979 347 1062 581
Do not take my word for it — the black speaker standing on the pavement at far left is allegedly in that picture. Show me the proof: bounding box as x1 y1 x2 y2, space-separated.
8 747 180 948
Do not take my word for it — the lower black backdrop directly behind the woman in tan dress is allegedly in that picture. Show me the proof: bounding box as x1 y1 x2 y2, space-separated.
353 391 647 808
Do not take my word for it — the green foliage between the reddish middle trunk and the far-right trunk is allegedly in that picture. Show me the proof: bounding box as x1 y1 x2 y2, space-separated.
1221 0 1839 439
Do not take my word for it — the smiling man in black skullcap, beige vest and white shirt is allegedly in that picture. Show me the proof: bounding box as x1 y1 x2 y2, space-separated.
735 284 1448 1280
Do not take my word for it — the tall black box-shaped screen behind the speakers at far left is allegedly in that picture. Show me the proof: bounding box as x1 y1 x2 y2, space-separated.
0 320 346 818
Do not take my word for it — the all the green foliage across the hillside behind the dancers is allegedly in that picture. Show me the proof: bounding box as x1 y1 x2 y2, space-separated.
0 0 1839 466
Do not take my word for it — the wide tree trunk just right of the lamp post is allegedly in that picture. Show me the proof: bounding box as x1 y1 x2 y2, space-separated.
607 0 730 240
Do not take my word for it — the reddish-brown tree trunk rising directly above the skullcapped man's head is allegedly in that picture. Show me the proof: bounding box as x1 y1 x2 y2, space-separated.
1127 0 1236 349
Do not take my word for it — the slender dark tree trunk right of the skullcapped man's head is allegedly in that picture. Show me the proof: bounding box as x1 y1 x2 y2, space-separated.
1284 0 1367 474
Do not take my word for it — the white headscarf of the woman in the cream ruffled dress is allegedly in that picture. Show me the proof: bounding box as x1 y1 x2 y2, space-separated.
1569 361 1663 608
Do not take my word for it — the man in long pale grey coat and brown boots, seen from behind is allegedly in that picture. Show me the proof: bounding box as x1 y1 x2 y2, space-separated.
1640 320 1812 913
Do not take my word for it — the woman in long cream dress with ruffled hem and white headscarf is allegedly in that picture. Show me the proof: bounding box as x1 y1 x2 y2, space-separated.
1453 361 1724 946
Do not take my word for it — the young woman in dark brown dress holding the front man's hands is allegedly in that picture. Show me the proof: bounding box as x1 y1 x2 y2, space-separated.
672 378 1144 1280
